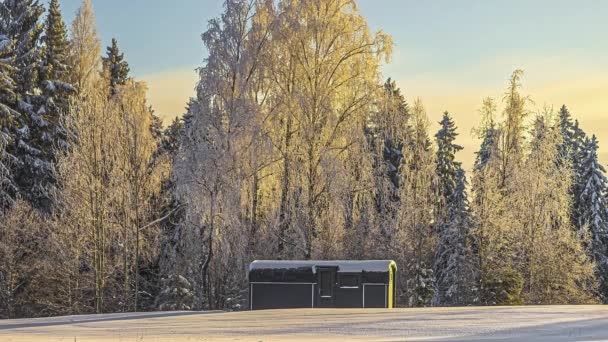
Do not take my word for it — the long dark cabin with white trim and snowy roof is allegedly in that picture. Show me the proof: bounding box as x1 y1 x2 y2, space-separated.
249 260 397 310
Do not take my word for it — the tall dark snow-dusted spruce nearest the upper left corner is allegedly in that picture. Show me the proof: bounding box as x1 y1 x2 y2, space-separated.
0 0 55 210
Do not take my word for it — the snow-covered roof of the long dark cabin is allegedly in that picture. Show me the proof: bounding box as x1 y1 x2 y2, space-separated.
249 260 397 273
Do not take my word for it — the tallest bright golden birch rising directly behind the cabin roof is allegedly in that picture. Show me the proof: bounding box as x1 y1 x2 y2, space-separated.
280 0 392 259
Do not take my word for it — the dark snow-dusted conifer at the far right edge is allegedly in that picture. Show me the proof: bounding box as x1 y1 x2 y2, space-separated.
578 135 608 302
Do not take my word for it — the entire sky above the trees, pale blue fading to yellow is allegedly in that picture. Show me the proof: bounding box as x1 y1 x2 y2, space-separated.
51 0 608 165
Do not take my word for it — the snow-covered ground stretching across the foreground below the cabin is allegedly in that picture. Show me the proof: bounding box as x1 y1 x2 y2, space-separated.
0 306 608 342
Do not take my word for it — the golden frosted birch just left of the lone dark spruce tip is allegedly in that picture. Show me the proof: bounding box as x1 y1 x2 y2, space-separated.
59 78 121 313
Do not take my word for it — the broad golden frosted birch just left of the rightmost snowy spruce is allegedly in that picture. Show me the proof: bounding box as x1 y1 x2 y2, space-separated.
507 112 595 304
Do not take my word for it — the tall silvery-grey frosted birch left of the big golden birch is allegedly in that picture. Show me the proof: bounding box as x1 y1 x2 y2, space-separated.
174 0 265 308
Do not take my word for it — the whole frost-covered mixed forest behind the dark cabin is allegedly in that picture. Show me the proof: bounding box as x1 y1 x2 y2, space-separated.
0 0 608 318
